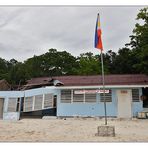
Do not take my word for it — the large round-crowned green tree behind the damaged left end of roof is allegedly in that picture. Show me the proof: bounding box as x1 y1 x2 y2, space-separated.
38 49 78 76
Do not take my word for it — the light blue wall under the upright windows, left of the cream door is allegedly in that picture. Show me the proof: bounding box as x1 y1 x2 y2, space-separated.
57 89 117 116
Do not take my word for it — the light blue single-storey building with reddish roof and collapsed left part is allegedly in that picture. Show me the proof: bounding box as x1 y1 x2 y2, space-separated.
0 74 148 120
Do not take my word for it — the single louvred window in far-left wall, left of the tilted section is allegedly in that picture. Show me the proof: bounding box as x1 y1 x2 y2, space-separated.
7 98 18 112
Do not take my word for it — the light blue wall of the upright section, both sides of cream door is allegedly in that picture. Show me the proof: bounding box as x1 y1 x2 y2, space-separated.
57 88 143 117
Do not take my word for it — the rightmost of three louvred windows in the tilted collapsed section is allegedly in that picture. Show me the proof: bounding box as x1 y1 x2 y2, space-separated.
44 94 53 108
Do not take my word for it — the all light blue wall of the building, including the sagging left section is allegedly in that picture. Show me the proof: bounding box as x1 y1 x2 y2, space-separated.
0 87 143 116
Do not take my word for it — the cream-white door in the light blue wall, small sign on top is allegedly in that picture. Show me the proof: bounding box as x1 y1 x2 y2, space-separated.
117 89 132 118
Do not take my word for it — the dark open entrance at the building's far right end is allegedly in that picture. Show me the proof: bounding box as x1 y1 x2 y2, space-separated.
141 87 148 109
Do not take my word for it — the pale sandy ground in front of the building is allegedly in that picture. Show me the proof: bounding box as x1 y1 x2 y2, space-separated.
0 118 148 142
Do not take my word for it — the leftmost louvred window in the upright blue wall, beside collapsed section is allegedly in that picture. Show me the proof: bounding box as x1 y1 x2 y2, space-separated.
61 90 71 103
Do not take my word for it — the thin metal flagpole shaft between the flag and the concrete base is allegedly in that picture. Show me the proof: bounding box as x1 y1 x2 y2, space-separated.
101 50 107 125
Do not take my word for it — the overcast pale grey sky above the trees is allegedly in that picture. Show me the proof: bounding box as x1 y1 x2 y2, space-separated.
0 5 144 61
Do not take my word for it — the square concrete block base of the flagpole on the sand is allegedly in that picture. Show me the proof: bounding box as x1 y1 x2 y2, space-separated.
95 125 115 137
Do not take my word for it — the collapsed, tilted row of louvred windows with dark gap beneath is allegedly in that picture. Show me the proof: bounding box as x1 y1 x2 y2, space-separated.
21 94 57 118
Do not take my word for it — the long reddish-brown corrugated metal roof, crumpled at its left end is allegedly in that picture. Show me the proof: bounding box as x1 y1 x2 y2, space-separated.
27 74 148 86
